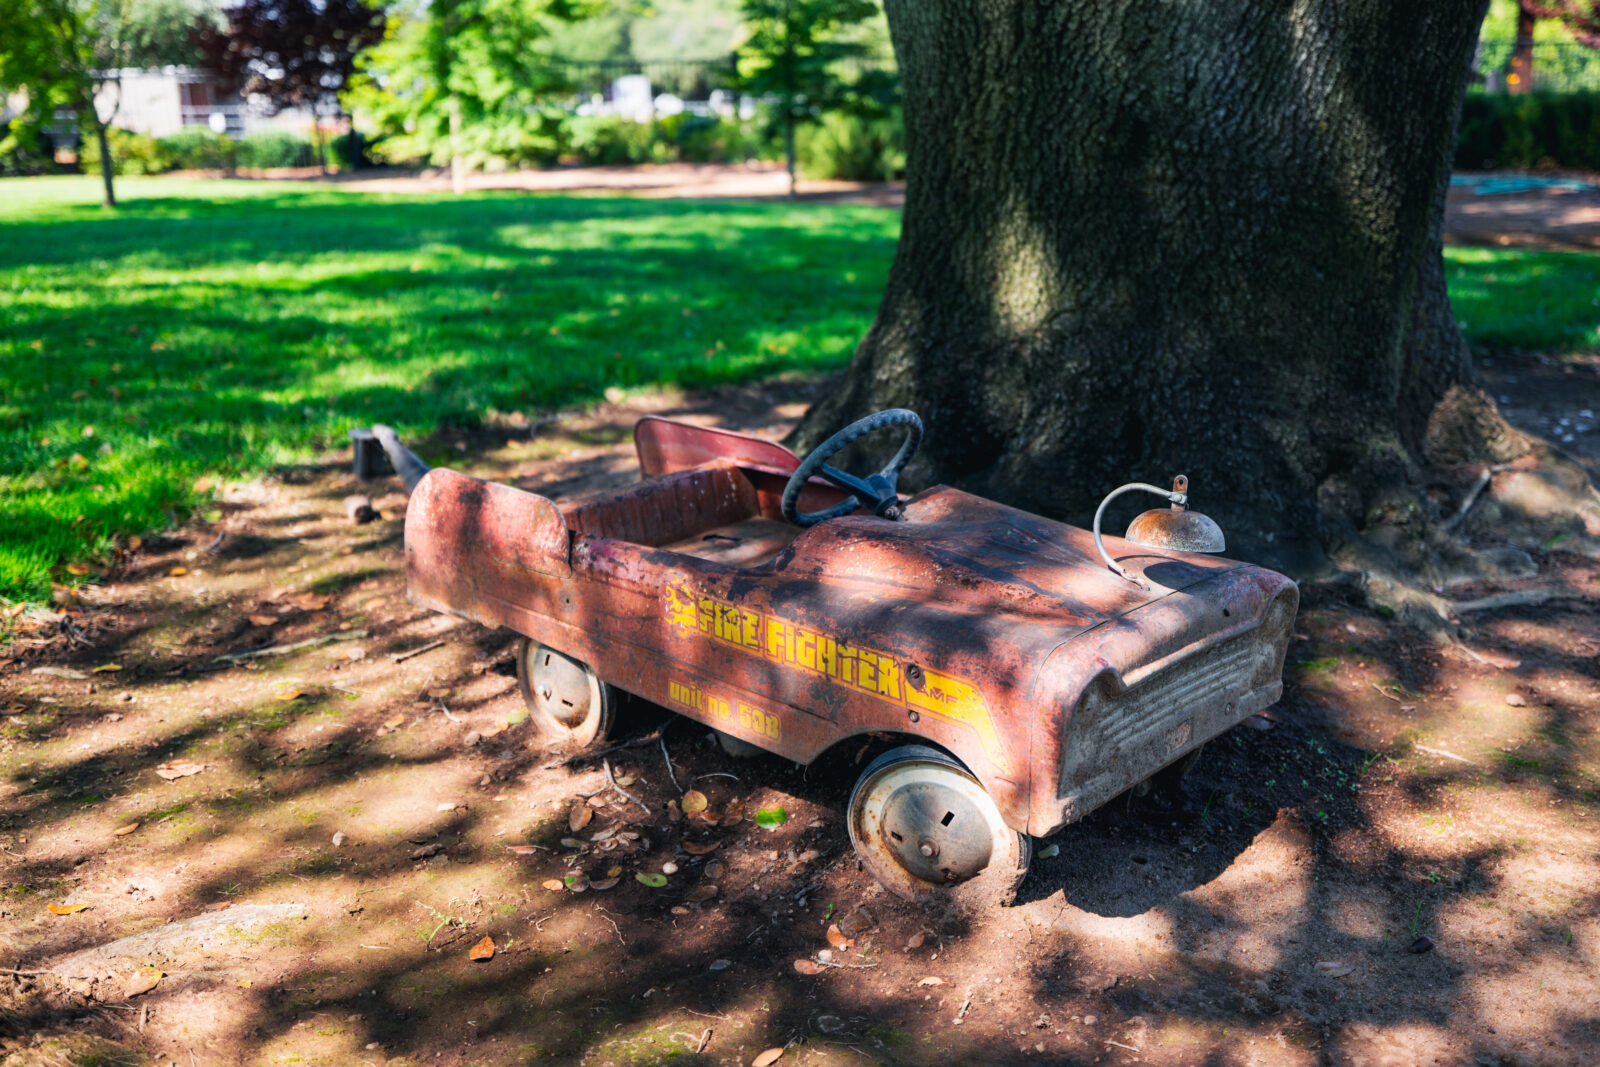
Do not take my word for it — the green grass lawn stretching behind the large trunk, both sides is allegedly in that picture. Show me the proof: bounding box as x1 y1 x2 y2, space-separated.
0 178 1600 598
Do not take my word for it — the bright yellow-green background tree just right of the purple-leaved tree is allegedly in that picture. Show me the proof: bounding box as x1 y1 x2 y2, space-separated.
352 0 594 194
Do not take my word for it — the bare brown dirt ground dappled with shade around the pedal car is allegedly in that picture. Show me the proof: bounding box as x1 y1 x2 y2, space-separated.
0 387 1600 1064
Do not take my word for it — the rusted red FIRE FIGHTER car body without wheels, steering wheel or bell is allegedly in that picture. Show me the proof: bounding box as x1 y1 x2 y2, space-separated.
406 421 1296 835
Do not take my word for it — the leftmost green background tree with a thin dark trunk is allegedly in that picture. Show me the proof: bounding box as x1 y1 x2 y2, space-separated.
0 0 133 208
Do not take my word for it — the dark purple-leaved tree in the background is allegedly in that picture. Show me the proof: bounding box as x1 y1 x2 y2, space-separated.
197 0 386 170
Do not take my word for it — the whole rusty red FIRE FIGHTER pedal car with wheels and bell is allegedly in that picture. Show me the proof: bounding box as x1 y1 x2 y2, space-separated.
400 410 1298 897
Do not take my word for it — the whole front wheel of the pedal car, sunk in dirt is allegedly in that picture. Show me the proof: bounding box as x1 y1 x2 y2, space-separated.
848 745 1032 902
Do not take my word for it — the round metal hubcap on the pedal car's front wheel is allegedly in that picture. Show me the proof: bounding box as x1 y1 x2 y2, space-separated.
880 781 994 883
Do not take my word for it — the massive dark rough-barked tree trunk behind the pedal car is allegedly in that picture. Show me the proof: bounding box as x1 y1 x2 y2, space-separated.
795 0 1510 575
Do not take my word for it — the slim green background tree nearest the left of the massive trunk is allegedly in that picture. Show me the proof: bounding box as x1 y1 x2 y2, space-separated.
739 0 896 197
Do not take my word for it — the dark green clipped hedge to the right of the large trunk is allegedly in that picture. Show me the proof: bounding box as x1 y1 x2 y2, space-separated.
1456 93 1600 170
